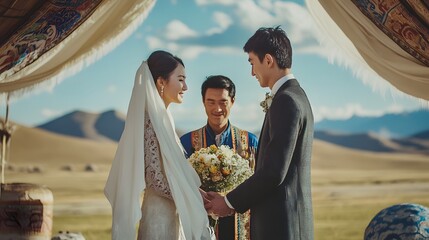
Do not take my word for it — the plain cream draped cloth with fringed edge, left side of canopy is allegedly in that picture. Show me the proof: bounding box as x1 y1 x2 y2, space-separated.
0 0 156 96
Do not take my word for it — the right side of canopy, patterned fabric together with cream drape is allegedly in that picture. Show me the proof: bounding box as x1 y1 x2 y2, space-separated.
306 0 429 102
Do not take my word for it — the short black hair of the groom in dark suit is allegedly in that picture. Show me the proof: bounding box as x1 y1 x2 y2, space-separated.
243 26 292 69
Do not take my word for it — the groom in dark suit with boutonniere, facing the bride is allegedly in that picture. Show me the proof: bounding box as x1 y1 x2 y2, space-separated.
205 27 314 240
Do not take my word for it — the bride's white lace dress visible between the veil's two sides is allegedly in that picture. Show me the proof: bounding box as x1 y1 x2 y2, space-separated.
137 114 182 240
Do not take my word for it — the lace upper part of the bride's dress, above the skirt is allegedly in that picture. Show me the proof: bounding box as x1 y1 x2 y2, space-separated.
144 114 172 199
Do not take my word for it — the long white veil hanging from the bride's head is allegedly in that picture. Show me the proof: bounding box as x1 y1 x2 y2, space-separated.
104 62 209 240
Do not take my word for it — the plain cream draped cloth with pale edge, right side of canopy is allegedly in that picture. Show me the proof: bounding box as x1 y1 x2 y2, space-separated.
306 0 429 103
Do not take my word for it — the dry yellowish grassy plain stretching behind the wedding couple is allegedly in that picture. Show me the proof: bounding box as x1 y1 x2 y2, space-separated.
5 127 429 240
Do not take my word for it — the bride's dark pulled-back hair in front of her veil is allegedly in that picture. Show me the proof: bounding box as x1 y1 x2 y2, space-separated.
147 50 185 83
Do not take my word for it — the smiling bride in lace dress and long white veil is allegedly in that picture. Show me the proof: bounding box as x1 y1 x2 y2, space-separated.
104 51 210 240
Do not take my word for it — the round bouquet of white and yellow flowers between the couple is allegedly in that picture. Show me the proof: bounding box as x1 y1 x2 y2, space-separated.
188 145 253 193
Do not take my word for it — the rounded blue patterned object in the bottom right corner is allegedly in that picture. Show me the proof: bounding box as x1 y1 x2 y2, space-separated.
365 203 429 240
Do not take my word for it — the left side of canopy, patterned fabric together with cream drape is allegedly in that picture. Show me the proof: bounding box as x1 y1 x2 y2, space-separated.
0 0 154 97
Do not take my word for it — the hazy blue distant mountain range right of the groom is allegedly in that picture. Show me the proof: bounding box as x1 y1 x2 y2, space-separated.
315 110 429 138
